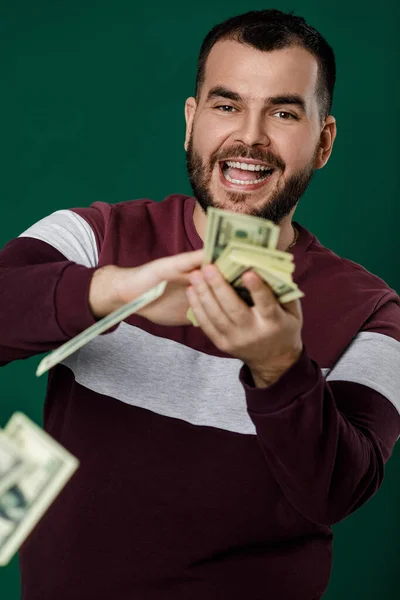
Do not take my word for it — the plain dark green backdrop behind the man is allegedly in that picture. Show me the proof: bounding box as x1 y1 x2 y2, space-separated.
0 0 400 600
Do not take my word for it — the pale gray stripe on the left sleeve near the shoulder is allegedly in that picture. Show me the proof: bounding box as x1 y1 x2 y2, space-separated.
18 210 98 267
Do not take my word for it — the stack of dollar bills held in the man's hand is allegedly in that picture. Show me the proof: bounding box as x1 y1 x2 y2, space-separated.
187 207 304 326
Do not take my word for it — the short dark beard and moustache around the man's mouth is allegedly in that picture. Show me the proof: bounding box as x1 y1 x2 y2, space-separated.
186 135 319 225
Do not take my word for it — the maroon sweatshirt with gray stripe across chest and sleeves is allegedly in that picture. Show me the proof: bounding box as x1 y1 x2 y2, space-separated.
0 195 400 600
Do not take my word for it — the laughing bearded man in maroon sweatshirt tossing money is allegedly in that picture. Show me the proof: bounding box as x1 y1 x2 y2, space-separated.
0 10 400 600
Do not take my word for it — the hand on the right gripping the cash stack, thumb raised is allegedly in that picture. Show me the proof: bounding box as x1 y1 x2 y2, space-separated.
187 265 303 387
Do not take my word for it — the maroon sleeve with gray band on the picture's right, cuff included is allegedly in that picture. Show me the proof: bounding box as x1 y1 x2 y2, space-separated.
240 293 400 525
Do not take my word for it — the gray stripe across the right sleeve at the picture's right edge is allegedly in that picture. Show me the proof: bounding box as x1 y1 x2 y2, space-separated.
326 331 400 413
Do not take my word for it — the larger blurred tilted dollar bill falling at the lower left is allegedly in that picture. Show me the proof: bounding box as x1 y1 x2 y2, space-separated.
0 413 79 565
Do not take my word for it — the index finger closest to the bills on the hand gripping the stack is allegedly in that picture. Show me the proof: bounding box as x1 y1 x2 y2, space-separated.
202 265 250 325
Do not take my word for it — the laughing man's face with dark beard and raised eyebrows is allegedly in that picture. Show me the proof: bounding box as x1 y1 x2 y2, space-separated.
185 40 332 224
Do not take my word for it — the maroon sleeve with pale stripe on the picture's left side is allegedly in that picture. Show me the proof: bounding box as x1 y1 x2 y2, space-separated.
0 209 104 365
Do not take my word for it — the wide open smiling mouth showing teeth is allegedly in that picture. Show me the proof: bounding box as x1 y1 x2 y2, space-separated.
219 160 275 190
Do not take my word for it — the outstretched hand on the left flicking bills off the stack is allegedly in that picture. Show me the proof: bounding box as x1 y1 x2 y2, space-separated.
89 250 204 325
